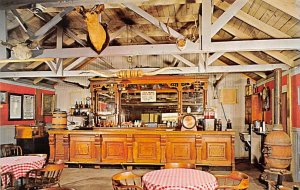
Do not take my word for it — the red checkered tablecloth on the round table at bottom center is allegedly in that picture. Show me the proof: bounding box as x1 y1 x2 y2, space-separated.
142 168 218 190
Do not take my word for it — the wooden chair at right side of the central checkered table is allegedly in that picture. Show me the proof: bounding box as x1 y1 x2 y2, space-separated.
215 171 250 190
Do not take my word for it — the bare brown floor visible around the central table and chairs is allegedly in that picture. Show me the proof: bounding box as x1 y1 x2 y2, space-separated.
61 161 265 190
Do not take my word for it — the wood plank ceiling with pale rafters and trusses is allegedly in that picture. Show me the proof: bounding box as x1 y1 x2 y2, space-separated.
0 0 300 83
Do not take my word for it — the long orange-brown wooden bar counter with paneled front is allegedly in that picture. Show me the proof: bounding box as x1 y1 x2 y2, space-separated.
49 128 235 170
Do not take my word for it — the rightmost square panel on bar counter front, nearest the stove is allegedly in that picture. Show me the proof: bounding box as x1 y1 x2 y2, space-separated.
201 135 232 166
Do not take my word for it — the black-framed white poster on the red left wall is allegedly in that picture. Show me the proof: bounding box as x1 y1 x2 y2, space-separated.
8 94 22 120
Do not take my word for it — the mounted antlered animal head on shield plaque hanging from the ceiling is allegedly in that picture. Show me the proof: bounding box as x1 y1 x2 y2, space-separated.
76 5 109 54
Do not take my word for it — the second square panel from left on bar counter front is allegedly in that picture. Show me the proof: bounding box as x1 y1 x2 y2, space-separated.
102 135 127 163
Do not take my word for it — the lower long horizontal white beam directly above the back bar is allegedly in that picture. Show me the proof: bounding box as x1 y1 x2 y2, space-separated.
0 64 289 78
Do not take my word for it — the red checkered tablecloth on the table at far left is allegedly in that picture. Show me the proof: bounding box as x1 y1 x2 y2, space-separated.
0 156 45 179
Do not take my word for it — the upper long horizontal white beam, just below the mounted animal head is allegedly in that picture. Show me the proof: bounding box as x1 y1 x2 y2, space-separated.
25 36 300 58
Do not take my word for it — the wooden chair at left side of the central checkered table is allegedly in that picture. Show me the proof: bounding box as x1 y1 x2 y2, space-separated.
112 171 143 190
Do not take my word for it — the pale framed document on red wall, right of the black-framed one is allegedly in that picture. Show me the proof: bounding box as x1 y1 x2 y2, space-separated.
23 94 35 119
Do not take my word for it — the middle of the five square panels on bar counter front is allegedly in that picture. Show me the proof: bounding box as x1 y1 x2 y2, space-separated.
133 135 161 163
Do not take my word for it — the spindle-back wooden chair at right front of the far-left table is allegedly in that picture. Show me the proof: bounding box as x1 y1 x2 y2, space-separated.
25 163 64 189
